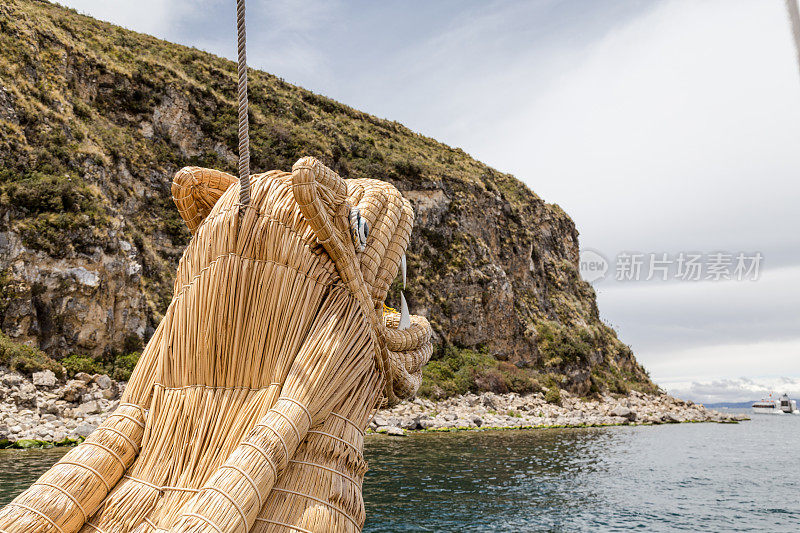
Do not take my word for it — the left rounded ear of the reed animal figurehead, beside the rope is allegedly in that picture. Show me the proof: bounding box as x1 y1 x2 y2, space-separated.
172 167 239 235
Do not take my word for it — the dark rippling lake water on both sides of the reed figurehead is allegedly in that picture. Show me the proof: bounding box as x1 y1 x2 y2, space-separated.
0 415 800 533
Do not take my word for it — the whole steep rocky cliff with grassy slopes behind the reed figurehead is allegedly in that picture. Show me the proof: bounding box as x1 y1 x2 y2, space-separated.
0 0 654 395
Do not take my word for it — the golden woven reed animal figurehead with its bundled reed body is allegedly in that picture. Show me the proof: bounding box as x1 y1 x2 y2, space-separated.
0 158 431 533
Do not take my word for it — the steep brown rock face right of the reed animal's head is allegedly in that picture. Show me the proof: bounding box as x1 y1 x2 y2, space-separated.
390 175 648 386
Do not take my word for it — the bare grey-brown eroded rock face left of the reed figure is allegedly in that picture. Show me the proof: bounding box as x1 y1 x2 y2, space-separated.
0 231 153 357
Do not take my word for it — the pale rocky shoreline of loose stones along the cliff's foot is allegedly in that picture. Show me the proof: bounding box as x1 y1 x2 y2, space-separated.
0 368 748 448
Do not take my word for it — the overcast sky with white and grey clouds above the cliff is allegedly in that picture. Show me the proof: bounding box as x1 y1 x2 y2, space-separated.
56 0 800 401
